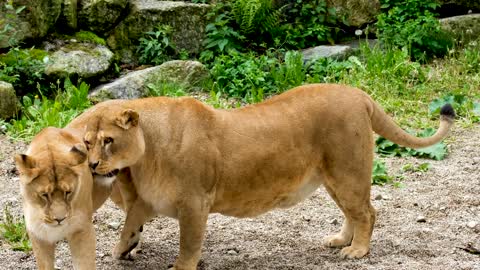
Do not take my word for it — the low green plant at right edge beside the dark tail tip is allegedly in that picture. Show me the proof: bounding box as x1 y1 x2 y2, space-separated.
428 94 480 122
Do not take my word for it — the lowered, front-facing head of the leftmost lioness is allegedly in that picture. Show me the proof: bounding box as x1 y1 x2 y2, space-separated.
15 128 91 230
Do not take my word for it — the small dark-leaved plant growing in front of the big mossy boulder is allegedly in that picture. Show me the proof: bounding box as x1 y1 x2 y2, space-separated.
137 25 176 65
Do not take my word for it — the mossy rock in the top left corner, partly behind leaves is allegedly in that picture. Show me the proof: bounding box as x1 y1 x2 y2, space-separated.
0 0 64 48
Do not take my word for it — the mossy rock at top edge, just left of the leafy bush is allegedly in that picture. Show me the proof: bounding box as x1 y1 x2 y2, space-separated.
327 0 380 27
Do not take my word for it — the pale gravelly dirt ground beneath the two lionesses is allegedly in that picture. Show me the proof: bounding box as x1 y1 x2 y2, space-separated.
0 126 480 270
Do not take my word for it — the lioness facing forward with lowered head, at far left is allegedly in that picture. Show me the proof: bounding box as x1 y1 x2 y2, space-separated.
15 128 95 270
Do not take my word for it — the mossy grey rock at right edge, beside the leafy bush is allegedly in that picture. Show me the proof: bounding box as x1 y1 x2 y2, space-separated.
440 14 480 43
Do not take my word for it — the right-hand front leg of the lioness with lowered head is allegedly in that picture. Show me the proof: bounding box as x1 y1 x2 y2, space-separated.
67 224 96 270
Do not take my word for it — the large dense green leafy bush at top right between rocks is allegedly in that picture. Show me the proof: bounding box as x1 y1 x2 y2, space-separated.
376 0 453 61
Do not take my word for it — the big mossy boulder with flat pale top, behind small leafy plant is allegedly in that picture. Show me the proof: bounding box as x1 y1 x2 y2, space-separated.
107 0 210 63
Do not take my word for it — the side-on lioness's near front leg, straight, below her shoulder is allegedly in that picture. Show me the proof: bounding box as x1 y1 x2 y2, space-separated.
170 199 209 270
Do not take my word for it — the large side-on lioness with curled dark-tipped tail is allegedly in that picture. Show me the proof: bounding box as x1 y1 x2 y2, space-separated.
80 84 454 270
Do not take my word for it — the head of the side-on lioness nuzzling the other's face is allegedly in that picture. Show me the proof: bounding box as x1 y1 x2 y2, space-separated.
84 106 145 179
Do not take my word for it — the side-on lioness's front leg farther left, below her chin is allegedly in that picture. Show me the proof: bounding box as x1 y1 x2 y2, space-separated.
113 198 155 259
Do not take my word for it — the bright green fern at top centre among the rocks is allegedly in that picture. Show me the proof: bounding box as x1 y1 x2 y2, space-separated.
232 0 285 35
